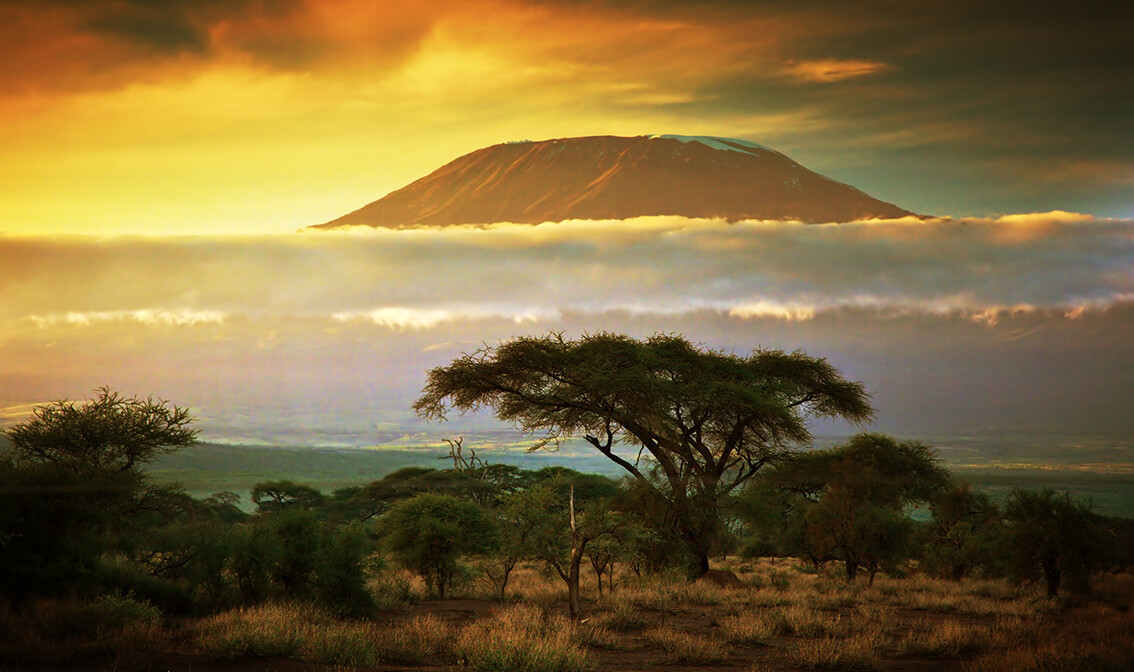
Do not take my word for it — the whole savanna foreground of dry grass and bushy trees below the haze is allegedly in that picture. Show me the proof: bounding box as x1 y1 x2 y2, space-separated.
0 371 1134 672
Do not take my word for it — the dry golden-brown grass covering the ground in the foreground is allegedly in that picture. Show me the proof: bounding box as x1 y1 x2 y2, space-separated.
0 561 1134 672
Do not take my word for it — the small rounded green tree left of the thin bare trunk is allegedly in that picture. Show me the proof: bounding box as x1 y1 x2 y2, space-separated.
381 493 497 599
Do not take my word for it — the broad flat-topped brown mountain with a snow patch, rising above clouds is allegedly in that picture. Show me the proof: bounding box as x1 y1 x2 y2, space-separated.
313 135 913 229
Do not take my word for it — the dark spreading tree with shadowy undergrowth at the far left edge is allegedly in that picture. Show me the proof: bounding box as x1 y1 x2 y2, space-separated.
0 388 196 602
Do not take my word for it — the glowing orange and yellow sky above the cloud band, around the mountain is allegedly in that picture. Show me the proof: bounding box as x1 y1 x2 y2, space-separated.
0 0 1134 233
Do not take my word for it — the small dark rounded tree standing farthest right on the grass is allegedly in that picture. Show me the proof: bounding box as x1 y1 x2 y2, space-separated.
1004 488 1103 597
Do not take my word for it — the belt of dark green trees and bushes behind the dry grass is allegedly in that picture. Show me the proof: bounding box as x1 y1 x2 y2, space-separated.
0 390 1134 615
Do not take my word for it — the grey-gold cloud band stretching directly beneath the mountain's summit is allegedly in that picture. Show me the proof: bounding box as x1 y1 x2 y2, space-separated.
0 212 1134 330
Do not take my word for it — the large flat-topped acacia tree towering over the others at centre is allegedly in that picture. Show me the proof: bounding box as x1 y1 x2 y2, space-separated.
414 333 873 576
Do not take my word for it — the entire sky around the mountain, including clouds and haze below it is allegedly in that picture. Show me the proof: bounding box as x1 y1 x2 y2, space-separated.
0 0 1134 451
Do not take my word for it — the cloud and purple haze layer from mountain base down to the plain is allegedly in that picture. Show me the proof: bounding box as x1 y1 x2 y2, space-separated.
0 212 1134 445
